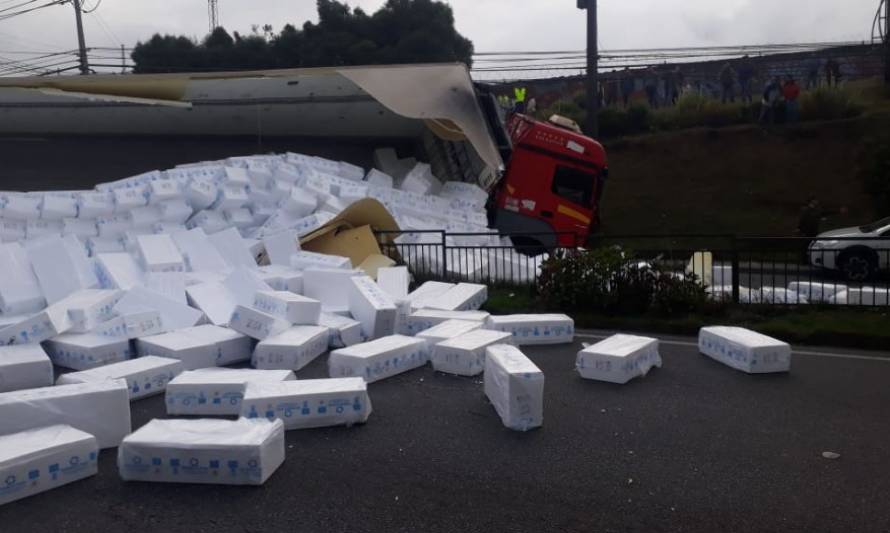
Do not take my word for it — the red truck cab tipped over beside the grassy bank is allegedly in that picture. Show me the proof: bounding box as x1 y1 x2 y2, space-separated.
495 114 608 247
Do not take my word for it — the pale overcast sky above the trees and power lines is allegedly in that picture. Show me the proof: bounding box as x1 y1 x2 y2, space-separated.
0 0 879 55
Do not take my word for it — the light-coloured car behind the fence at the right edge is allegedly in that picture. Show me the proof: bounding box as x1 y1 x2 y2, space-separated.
809 217 890 281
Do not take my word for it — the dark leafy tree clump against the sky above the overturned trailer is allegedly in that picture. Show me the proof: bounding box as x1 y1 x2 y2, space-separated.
132 0 473 73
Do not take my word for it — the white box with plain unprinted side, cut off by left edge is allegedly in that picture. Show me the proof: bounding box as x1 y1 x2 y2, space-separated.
0 380 130 449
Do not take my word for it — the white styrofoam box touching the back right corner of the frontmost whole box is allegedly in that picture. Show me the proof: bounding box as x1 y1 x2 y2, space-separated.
241 378 371 431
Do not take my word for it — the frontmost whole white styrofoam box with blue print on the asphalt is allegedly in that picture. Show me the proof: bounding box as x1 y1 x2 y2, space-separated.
117 418 284 485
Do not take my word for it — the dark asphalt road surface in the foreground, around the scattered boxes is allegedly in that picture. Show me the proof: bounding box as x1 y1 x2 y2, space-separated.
0 332 890 533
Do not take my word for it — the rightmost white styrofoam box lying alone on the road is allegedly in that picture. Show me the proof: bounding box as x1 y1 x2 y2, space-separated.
698 326 791 374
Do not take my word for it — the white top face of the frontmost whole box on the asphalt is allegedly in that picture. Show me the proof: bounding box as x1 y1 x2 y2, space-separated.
123 418 284 449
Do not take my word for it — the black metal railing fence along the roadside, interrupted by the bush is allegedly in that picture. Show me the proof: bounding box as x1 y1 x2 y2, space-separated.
378 231 890 307
